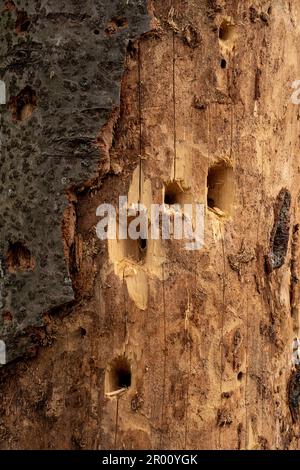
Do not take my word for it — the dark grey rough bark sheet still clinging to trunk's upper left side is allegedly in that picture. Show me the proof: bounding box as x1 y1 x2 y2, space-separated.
0 0 152 362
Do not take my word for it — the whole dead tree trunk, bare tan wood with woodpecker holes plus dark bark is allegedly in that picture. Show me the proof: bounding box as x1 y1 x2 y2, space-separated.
0 0 300 449
